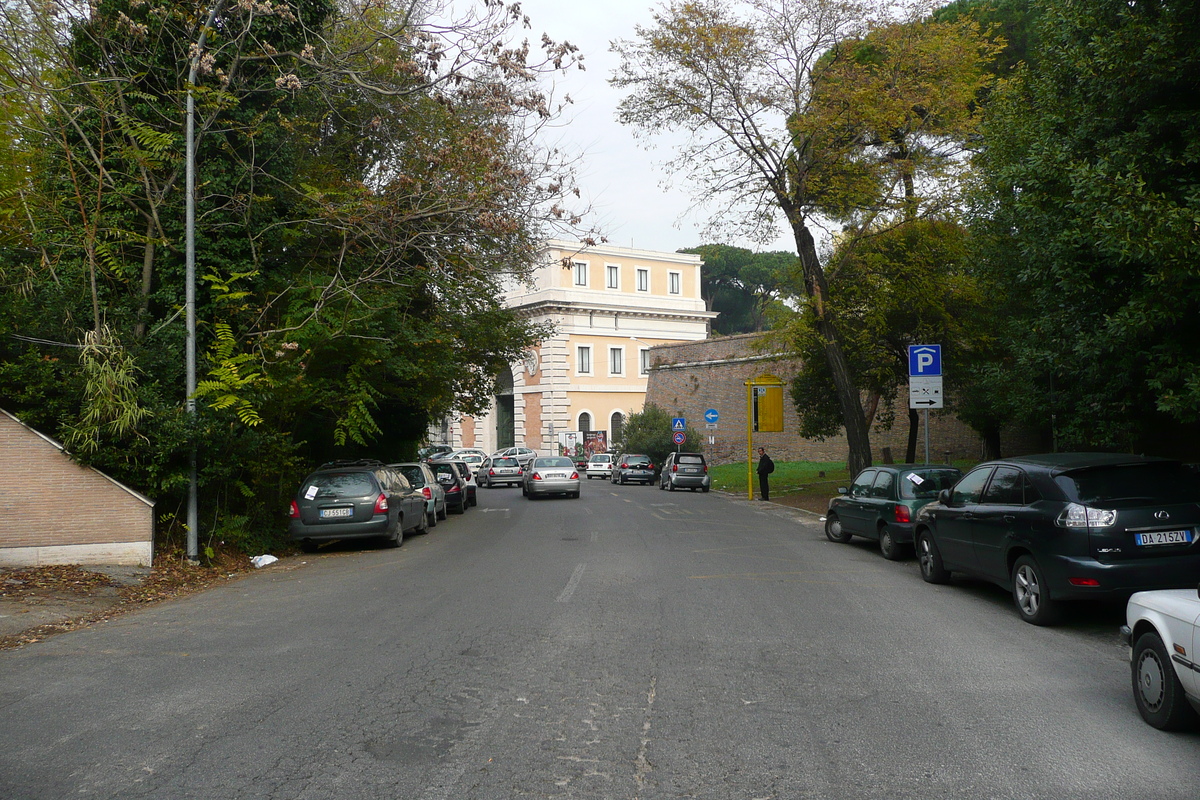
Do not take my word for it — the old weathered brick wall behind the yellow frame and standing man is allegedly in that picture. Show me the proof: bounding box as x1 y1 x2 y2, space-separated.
646 333 1038 464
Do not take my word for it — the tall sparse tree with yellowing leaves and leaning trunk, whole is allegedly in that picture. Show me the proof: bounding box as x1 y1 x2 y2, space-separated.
612 0 989 470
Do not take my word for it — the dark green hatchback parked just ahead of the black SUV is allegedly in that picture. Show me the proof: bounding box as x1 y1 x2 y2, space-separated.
826 464 962 560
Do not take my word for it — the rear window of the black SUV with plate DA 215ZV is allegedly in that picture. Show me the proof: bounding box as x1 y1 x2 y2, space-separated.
1055 462 1200 507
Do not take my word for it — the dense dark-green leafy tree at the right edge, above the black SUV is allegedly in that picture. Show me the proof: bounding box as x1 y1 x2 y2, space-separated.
976 0 1200 453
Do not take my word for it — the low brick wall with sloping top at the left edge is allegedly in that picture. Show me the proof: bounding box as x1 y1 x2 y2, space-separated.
0 411 154 565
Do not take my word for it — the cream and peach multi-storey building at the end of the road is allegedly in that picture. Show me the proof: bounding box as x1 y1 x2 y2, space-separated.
446 240 716 452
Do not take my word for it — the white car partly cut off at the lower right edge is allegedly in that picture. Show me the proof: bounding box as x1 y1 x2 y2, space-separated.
1121 588 1200 730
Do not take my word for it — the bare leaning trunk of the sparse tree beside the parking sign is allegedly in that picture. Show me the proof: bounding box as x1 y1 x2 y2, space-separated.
788 215 871 475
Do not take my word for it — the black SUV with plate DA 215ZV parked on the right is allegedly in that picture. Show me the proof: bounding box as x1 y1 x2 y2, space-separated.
913 453 1200 625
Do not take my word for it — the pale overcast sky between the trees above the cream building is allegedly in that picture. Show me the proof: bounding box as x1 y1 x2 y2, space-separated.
521 0 794 252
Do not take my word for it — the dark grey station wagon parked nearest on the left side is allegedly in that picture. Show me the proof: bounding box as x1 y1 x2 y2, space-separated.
288 459 428 553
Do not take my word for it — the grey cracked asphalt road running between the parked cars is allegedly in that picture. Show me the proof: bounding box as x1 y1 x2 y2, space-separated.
0 481 1200 800
